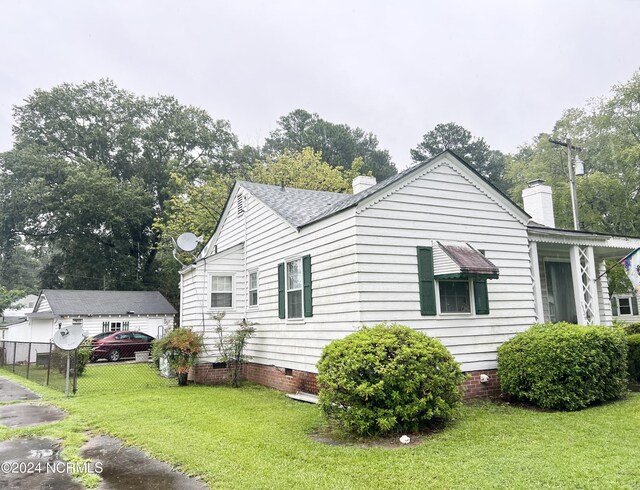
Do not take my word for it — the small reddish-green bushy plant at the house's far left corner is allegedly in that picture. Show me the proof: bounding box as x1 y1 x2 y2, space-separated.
151 328 204 386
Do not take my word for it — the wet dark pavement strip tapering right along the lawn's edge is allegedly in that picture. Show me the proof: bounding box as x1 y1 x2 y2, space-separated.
80 436 208 490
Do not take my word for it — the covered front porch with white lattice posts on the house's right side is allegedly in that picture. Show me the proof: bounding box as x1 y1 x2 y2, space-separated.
529 226 640 325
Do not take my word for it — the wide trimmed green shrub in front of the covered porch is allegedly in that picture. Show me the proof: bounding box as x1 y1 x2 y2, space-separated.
498 323 627 410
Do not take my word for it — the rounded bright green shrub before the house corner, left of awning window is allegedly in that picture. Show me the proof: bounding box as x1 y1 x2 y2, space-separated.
318 324 465 435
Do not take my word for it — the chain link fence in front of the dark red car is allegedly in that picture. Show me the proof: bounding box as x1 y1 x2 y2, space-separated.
0 339 177 395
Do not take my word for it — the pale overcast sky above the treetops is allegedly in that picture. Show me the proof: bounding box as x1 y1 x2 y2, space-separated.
0 0 640 168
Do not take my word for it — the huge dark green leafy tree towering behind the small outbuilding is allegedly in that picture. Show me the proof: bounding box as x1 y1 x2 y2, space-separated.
0 80 239 289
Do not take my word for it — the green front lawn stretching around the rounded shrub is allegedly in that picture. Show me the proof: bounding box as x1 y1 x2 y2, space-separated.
0 372 640 488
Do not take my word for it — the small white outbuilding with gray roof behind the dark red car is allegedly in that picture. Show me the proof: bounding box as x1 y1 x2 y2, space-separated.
21 289 176 342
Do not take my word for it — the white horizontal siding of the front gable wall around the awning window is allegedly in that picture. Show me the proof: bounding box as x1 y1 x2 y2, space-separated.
356 161 535 371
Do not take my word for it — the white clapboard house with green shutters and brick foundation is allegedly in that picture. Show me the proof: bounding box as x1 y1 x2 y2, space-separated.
180 151 640 391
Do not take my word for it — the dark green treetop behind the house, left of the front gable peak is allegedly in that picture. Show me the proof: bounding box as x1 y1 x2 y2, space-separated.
264 109 397 181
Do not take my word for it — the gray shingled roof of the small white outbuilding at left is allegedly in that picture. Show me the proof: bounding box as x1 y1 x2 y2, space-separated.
42 289 176 315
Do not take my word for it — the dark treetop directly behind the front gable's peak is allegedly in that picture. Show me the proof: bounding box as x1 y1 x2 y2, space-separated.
411 123 507 191
